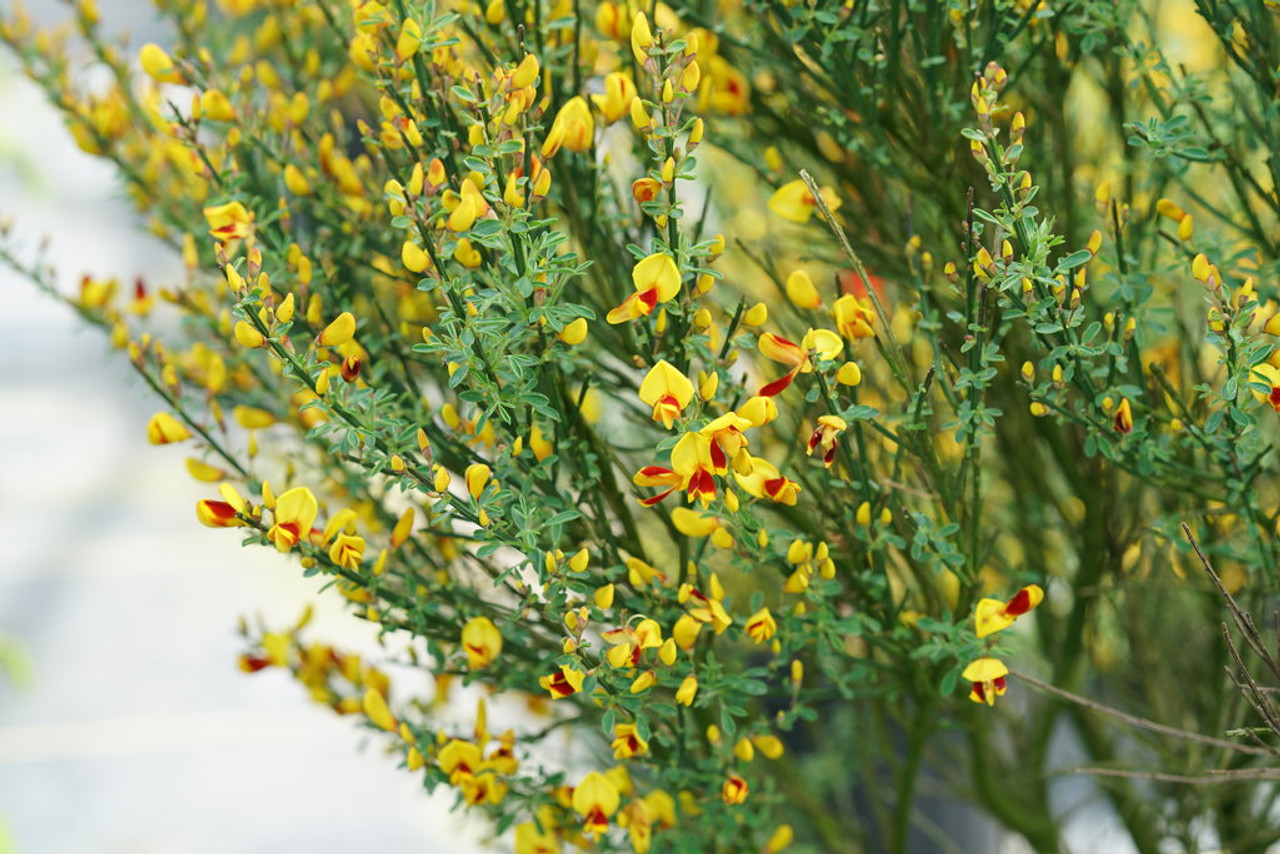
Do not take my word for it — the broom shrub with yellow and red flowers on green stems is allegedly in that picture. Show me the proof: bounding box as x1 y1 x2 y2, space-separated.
0 0 1280 854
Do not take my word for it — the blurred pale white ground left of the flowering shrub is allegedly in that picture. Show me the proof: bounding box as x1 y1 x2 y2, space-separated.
0 0 483 854
